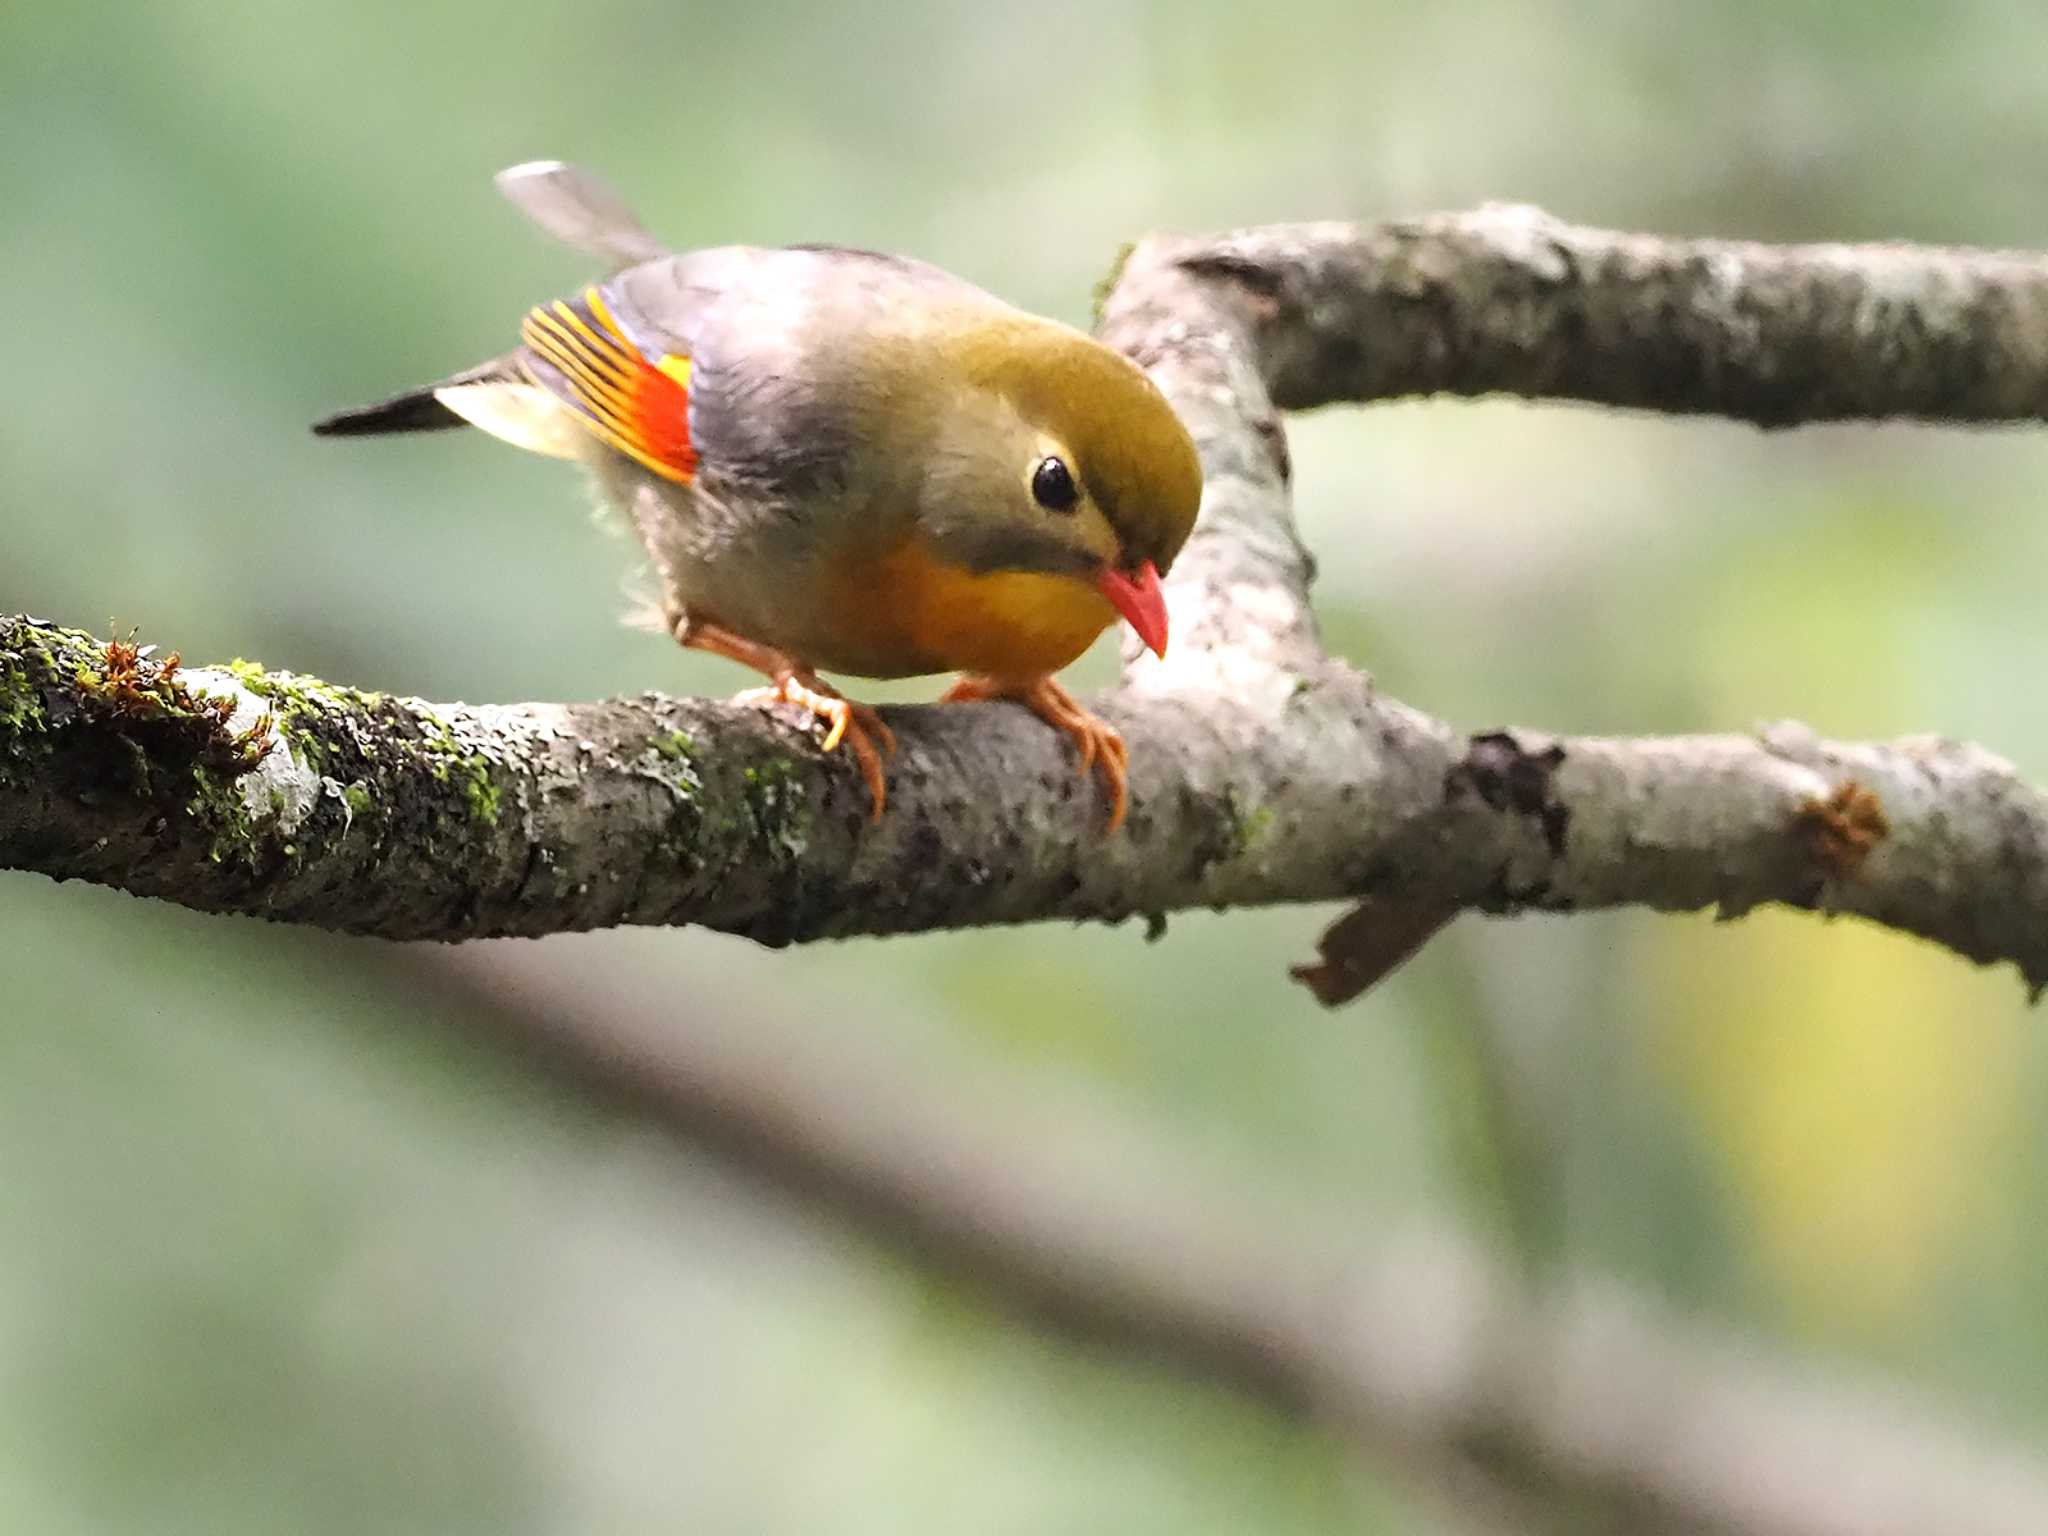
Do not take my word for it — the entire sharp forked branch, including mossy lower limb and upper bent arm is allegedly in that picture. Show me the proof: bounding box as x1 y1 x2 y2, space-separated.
0 209 2048 987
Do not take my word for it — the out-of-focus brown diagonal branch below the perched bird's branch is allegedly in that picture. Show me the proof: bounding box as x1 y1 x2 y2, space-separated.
418 942 2048 1536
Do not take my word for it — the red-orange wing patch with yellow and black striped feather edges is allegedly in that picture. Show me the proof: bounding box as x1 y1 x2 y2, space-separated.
520 287 696 485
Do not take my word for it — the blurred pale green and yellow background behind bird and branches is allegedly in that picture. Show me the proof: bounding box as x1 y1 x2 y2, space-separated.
0 0 2048 1536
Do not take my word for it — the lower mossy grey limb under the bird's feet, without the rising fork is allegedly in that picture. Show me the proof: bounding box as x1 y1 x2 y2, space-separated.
0 618 2048 999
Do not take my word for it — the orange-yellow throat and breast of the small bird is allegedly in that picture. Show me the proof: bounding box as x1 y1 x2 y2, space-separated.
825 537 1116 678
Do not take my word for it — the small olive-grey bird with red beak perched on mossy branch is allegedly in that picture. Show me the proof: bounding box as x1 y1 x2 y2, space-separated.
313 160 1202 834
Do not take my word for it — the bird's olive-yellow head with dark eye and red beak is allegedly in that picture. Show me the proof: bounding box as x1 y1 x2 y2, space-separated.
918 311 1202 655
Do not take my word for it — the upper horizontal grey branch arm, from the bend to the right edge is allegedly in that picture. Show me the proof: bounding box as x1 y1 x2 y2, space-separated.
1180 205 2048 426
